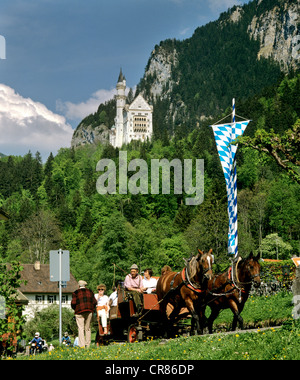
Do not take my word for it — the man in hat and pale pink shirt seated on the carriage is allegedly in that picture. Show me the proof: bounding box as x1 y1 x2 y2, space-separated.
124 264 143 316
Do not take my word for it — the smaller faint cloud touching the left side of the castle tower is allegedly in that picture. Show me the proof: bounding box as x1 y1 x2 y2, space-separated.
56 89 117 121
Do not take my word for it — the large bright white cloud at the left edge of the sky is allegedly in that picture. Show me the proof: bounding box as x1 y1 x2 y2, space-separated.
0 84 73 159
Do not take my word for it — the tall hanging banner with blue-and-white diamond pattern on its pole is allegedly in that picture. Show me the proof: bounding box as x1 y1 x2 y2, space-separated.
211 99 250 259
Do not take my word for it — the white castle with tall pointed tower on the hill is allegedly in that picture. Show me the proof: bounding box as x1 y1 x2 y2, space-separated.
109 69 153 148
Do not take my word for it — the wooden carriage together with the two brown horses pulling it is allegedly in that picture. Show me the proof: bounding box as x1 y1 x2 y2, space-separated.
96 251 260 343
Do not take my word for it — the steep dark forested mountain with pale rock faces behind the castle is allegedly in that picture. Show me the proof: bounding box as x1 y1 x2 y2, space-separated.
72 0 300 146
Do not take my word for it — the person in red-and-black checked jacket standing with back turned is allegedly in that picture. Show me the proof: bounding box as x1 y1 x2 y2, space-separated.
71 280 97 348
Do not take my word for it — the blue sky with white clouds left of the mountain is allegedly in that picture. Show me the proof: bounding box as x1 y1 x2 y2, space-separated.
0 0 248 157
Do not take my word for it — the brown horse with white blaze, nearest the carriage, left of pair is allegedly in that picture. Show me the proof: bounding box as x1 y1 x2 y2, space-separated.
156 249 213 334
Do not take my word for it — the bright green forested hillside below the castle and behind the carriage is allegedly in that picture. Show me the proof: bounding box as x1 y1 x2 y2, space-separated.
0 74 300 287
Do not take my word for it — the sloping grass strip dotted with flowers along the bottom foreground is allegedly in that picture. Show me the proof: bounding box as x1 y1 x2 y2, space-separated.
17 320 300 361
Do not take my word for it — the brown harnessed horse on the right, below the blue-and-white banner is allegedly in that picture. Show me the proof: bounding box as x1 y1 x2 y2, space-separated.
202 253 260 334
